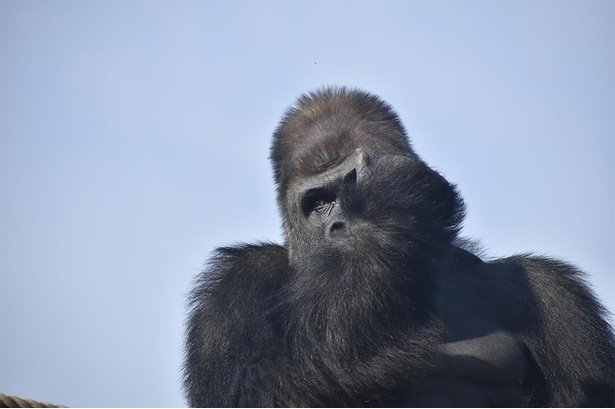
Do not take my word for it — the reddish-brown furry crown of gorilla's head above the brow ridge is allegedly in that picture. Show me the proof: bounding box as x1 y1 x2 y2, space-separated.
271 88 415 201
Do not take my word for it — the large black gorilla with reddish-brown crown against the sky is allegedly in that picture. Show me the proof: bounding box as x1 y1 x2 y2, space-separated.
184 87 615 407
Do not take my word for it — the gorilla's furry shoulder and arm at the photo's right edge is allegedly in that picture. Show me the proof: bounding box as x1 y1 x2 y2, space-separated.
516 256 615 407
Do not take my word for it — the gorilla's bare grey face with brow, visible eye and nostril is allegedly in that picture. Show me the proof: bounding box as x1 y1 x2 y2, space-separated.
286 148 401 259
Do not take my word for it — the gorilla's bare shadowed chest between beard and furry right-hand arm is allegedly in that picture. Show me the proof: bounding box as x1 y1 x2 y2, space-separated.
387 246 529 407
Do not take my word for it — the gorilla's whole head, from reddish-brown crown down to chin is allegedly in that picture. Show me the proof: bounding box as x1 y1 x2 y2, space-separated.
271 88 463 278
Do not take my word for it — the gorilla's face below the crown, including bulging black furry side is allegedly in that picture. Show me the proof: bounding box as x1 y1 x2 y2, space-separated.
284 132 460 271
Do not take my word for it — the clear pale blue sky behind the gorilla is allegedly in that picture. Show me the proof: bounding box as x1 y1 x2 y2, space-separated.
0 0 615 406
